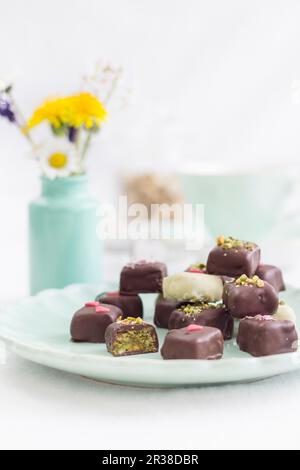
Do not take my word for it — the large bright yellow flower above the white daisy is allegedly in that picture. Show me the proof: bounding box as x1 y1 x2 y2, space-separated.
27 93 107 129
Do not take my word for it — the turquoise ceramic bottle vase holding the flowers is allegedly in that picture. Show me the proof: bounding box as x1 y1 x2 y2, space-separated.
29 175 102 294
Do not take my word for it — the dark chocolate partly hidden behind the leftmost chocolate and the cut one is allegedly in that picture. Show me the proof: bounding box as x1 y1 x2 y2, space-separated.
96 292 143 318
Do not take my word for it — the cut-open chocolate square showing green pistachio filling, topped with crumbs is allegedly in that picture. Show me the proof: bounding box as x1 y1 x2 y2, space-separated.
105 317 158 356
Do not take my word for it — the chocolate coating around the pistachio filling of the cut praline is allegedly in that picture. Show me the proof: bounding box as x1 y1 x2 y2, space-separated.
105 322 159 356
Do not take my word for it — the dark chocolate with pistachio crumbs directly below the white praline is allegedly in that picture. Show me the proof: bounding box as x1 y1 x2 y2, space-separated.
168 305 233 340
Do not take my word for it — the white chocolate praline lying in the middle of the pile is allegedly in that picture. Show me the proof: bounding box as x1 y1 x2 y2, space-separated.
163 272 223 302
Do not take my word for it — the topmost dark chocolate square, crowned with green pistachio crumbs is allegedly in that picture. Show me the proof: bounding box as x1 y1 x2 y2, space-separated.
207 237 260 278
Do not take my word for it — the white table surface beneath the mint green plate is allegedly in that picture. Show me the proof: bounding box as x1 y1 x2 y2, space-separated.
0 200 300 450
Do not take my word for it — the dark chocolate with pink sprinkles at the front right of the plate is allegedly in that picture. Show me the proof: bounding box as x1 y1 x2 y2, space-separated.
237 316 298 357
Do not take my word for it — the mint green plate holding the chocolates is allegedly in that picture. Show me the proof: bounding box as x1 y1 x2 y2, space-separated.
0 285 300 387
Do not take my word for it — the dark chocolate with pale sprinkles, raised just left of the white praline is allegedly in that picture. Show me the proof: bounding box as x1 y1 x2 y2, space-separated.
120 260 168 295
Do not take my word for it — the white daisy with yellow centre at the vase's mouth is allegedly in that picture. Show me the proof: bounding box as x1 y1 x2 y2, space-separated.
32 138 83 179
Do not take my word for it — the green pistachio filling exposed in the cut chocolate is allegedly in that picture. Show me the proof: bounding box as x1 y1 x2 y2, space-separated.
112 328 157 356
